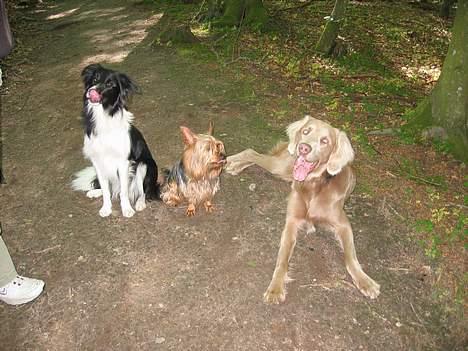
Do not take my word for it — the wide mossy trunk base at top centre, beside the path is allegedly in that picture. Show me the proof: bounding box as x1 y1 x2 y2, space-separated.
212 0 268 29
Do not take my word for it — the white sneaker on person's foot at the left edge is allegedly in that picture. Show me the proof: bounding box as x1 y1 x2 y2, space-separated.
0 275 44 305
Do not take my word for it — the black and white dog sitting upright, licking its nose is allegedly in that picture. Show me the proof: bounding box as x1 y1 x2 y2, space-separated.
72 64 160 217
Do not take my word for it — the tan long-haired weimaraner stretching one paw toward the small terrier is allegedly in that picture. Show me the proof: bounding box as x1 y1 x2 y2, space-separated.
226 116 380 303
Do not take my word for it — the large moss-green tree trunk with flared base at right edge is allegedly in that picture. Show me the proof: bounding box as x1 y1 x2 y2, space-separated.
408 0 468 162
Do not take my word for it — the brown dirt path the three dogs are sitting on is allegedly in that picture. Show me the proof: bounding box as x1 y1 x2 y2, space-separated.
0 1 450 351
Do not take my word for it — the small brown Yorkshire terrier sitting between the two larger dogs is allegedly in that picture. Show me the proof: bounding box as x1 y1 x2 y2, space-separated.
161 123 226 217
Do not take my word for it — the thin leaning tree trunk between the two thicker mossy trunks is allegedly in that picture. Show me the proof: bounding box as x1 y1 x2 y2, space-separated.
315 0 348 56
